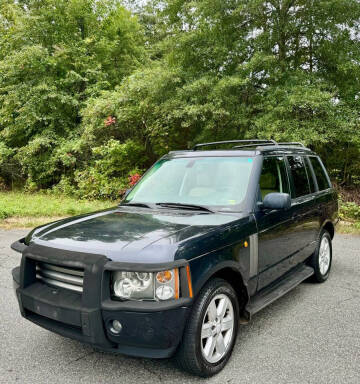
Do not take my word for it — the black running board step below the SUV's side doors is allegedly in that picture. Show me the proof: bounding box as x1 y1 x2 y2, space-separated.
245 264 314 320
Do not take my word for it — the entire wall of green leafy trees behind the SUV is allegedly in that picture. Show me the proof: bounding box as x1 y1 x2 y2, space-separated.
0 0 360 199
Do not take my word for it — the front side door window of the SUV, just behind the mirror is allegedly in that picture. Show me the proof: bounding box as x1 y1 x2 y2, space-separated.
260 157 289 199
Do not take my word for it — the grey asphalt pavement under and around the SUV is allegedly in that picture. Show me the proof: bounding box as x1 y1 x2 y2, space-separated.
0 231 360 384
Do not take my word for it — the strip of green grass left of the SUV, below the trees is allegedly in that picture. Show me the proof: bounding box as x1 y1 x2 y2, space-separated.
0 192 116 229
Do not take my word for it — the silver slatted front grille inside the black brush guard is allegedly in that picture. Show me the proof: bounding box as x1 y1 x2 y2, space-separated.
36 263 84 292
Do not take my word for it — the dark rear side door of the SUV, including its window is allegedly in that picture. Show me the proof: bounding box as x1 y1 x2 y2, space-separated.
287 155 320 266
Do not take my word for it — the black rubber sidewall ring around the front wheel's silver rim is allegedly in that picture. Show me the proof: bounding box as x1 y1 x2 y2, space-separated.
195 279 239 376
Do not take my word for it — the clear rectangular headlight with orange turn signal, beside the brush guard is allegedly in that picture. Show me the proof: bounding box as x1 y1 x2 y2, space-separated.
112 268 179 300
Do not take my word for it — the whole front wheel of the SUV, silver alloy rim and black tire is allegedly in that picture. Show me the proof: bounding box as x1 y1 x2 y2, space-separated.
176 278 239 377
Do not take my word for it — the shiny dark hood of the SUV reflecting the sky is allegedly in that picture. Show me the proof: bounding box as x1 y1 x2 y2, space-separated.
27 207 249 263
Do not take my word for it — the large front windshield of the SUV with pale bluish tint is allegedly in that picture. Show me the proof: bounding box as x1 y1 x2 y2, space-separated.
124 157 253 210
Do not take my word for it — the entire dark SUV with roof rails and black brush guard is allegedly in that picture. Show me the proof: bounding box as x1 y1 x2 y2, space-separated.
12 140 338 376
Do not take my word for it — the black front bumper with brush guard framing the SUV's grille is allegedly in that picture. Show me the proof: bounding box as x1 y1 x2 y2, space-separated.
12 242 192 358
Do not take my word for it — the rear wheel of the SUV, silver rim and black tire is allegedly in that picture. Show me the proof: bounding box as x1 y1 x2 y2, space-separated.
310 230 332 283
